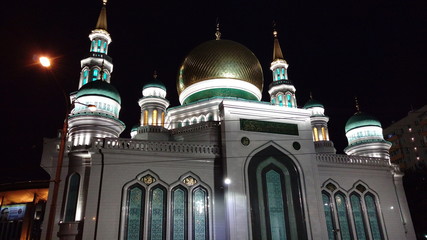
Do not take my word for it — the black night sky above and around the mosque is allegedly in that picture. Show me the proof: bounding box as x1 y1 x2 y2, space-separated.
0 0 427 182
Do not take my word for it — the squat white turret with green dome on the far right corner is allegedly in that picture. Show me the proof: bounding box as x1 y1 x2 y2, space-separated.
344 98 391 160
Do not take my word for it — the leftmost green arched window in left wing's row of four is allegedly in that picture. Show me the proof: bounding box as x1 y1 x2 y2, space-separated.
126 185 145 240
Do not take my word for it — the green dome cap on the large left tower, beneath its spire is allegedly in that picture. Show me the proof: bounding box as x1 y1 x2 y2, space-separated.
76 80 122 104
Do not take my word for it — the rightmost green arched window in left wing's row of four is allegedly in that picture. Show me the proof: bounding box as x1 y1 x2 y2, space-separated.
192 187 209 240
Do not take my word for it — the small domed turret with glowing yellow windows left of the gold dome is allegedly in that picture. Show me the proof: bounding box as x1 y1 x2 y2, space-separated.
131 71 169 140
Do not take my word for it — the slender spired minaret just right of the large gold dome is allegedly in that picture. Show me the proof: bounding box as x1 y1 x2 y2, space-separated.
268 26 297 108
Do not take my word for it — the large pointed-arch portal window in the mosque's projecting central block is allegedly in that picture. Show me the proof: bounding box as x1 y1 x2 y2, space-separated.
248 146 307 239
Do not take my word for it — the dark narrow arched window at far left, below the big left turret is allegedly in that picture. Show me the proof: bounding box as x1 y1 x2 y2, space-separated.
64 173 80 222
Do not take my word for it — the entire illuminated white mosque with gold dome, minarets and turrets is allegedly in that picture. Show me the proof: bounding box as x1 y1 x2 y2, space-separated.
42 1 415 240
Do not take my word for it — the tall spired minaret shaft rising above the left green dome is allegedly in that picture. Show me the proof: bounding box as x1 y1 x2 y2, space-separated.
79 0 113 88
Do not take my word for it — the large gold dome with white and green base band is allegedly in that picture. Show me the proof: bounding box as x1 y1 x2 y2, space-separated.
177 40 264 103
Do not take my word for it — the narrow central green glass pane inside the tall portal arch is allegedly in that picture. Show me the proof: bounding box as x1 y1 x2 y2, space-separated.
265 170 287 240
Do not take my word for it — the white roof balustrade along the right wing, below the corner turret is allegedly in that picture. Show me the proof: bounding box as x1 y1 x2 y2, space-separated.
316 153 393 169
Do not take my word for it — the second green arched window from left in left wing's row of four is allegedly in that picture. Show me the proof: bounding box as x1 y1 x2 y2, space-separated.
149 186 166 240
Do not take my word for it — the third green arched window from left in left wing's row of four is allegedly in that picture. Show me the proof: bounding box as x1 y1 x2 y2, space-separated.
171 187 187 240
